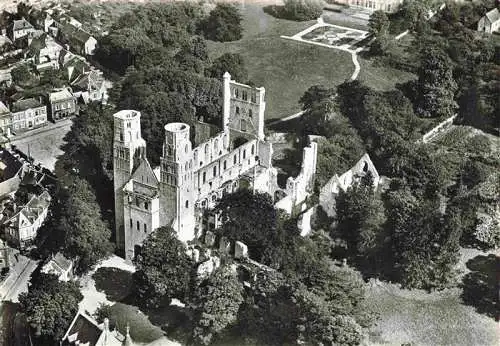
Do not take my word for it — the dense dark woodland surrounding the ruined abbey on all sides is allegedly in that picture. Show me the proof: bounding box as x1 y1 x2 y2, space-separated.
18 1 500 345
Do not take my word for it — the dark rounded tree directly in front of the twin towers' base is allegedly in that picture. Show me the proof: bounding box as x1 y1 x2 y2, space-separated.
134 227 193 307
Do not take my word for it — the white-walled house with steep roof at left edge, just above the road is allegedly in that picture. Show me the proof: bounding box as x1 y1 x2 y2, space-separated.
3 190 51 249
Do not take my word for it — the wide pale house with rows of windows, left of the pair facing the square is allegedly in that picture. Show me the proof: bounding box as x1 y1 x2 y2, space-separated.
12 98 47 132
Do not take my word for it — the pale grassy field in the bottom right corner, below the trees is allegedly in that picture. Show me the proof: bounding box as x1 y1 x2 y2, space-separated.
368 249 500 346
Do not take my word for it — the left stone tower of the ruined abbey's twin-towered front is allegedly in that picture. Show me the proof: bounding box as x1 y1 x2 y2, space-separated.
113 110 146 250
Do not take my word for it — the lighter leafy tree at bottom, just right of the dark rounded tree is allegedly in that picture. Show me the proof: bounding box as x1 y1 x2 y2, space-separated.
192 266 243 345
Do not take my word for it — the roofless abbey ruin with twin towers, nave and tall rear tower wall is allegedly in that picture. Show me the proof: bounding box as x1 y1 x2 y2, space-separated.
113 72 276 259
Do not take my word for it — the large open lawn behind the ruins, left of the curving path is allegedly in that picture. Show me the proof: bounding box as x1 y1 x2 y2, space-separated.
209 5 354 119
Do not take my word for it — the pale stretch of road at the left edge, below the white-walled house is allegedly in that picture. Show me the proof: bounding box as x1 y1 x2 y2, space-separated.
0 255 38 303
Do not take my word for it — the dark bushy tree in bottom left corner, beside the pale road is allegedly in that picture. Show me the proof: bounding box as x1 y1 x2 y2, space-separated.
19 273 83 345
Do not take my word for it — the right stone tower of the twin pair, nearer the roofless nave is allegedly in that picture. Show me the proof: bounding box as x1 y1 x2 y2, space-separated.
160 123 196 241
